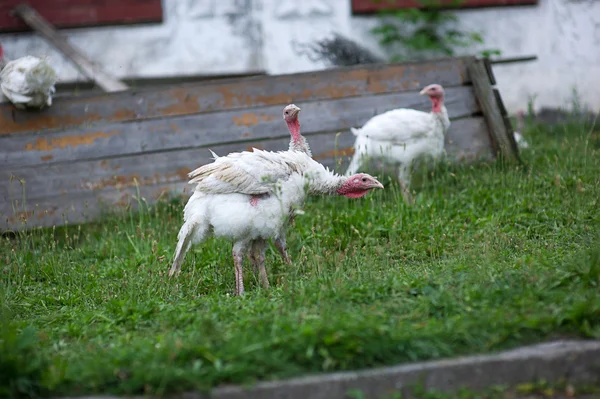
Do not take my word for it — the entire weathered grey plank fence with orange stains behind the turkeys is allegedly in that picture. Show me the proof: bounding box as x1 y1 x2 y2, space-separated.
0 57 518 231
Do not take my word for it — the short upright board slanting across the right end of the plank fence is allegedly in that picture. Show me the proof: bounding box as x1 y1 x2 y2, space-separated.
468 60 518 161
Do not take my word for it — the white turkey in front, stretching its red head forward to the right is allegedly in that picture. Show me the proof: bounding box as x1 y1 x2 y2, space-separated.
169 144 383 295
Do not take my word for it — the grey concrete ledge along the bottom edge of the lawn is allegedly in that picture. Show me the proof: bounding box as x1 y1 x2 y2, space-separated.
57 341 600 399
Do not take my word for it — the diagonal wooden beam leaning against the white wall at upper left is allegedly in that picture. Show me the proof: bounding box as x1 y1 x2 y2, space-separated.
14 4 129 92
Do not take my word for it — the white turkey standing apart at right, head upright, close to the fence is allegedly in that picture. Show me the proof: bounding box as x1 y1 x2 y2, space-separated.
346 84 450 202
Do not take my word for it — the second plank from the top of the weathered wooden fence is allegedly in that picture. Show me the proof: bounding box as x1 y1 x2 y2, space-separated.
0 86 479 169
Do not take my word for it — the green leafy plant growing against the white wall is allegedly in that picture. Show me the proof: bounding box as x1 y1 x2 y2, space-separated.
371 0 500 62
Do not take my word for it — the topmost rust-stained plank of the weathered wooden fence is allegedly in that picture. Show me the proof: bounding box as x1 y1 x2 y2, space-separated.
0 57 472 134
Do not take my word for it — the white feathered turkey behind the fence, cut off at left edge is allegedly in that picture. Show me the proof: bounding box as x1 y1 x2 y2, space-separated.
0 44 56 109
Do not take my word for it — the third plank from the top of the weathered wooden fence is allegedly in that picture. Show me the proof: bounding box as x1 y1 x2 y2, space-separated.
0 117 492 203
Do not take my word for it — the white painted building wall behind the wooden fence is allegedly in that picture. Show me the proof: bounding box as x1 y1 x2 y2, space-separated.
0 0 600 112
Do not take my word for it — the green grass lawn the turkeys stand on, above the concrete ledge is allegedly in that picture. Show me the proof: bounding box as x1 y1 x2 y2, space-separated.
0 118 600 397
